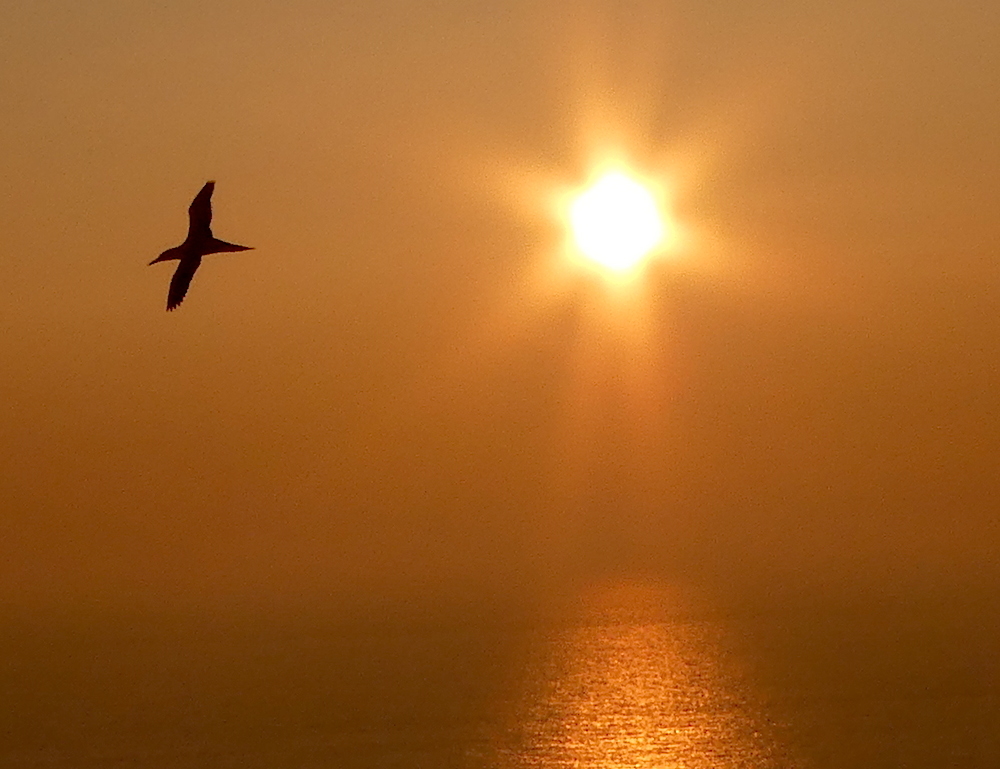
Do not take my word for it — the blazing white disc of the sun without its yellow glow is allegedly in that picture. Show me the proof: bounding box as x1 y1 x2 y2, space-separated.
569 172 664 272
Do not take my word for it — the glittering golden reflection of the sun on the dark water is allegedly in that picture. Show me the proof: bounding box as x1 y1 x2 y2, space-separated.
484 581 798 769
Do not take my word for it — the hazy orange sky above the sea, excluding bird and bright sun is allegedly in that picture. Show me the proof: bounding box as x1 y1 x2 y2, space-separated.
0 0 1000 604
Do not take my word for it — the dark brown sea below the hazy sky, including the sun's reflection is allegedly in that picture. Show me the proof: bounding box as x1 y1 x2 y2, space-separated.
0 581 1000 769
